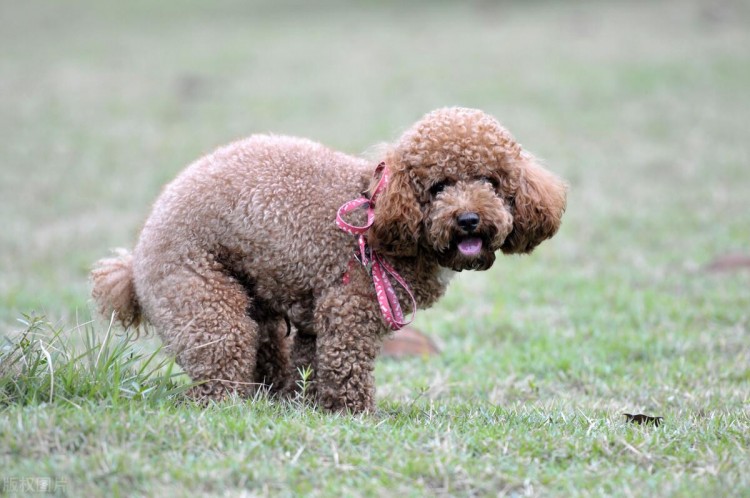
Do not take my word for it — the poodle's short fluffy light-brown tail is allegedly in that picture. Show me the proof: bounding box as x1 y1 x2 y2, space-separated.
91 249 142 328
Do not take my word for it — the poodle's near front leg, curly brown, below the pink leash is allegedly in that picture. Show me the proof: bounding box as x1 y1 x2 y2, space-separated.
315 282 387 413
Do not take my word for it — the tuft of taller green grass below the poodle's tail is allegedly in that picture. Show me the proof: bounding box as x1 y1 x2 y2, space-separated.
0 316 188 407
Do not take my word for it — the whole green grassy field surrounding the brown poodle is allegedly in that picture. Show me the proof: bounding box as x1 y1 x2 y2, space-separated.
0 0 750 496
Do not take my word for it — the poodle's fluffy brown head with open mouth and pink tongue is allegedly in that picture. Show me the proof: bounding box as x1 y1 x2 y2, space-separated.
368 108 566 271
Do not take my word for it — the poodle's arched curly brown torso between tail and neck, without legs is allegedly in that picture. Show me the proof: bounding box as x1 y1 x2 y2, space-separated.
134 135 372 312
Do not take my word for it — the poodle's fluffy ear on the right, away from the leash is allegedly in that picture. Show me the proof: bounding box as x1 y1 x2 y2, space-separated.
500 154 567 254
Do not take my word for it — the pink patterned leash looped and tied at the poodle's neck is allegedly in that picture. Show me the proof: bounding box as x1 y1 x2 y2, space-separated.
336 163 417 330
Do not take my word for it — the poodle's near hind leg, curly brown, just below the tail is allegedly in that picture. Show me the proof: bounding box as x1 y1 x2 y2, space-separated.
137 261 259 399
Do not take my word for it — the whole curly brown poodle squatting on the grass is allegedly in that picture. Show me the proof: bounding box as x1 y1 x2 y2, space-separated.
92 108 566 412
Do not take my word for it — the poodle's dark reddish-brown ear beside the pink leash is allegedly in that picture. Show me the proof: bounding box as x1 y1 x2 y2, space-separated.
368 166 422 256
